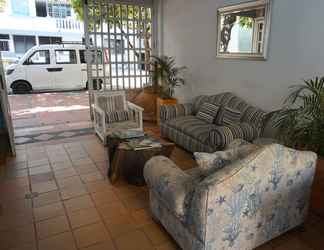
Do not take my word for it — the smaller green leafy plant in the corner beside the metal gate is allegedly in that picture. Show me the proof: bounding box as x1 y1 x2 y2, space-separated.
151 56 186 99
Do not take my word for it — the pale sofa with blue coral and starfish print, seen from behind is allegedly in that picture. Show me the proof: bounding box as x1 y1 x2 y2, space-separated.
144 144 317 250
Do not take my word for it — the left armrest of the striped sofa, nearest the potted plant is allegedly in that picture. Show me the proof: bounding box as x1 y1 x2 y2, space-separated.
160 103 193 123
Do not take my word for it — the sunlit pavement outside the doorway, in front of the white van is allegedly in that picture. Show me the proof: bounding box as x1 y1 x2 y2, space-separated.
9 91 92 144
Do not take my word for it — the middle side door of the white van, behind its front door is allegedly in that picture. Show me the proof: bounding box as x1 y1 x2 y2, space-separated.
54 49 84 89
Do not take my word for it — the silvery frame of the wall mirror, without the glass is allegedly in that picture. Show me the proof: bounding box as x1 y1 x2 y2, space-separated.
216 0 272 61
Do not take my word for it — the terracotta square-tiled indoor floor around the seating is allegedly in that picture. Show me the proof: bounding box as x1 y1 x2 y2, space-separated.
0 133 324 250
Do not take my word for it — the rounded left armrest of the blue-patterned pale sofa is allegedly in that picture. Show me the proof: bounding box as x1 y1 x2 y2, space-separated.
144 156 193 218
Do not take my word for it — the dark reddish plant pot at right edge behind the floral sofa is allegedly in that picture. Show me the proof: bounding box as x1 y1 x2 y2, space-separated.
310 157 324 218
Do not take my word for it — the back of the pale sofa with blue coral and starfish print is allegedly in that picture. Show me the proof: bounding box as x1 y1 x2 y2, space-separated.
191 144 317 249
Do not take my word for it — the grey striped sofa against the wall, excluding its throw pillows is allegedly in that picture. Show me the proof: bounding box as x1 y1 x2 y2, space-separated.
160 92 266 152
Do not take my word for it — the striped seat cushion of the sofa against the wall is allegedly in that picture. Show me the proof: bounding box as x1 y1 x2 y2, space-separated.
166 116 216 144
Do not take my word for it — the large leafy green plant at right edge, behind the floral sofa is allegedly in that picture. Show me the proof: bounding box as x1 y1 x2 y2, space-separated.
266 77 324 156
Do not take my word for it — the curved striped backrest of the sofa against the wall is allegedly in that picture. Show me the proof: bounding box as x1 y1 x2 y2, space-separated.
193 92 266 124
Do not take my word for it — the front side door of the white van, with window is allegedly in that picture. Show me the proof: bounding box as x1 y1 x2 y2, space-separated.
22 50 55 90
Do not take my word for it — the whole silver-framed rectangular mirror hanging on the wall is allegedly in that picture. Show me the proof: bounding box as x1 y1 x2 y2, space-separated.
217 0 271 60
